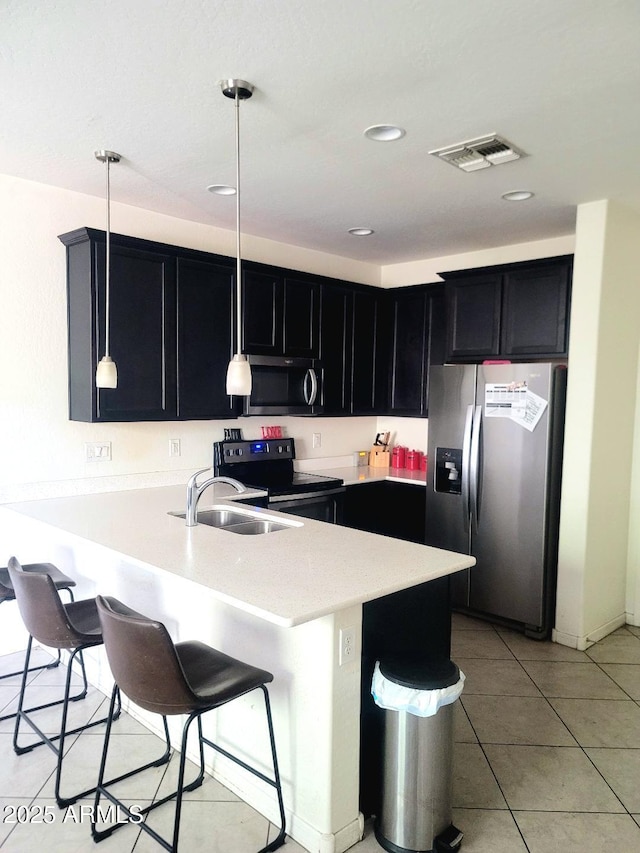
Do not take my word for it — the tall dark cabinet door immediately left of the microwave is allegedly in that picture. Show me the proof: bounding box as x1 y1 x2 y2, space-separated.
177 257 237 420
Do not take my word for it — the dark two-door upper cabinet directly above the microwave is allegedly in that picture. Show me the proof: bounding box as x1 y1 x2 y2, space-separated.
242 265 320 358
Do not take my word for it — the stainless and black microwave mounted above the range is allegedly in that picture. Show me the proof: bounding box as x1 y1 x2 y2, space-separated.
244 355 324 415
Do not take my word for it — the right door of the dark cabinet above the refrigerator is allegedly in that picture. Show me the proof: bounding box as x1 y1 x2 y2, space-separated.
501 263 571 358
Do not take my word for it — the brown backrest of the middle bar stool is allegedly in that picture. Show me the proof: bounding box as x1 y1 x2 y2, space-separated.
8 557 79 649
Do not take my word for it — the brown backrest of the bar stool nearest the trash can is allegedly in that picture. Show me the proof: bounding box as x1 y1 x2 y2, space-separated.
96 595 199 716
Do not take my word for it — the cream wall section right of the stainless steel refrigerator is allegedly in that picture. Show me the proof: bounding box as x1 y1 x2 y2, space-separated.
556 201 640 648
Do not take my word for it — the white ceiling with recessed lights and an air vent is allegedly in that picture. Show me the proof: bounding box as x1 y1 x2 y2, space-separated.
5 0 640 265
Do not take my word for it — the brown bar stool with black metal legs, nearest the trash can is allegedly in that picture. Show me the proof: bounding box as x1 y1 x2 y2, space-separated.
91 595 285 853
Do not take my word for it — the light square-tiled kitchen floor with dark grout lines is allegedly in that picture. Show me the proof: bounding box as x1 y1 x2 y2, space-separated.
0 615 640 853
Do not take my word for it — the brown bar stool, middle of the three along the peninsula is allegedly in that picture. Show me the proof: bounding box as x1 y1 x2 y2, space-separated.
8 557 130 808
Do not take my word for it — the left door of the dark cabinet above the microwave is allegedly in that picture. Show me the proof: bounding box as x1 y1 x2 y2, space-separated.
242 270 283 355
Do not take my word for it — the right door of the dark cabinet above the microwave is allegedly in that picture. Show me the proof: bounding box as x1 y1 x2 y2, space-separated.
283 277 320 358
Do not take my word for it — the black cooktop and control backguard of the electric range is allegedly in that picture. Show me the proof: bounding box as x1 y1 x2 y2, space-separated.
213 438 342 496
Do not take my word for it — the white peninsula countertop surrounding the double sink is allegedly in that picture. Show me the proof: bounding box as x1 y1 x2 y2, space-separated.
0 482 475 627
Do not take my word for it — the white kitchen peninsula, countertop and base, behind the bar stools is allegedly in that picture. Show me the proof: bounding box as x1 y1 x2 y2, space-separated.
0 485 474 853
